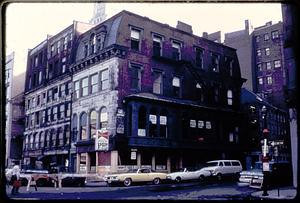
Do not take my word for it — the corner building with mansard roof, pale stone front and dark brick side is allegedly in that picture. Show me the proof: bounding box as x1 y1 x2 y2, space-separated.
71 11 246 174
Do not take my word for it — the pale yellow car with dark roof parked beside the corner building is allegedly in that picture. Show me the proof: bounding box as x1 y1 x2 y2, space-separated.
104 168 167 187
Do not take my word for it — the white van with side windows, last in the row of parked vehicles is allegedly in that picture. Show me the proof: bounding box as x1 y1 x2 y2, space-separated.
201 160 243 180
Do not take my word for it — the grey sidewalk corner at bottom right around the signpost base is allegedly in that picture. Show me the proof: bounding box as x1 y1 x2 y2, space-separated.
251 187 299 199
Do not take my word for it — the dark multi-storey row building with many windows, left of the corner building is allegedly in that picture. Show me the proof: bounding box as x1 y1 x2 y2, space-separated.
23 21 92 169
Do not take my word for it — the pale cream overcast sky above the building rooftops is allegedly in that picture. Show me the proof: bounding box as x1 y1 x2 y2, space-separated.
5 3 282 75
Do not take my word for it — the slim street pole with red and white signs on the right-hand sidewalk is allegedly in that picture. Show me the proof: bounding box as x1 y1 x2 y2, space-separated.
261 106 270 196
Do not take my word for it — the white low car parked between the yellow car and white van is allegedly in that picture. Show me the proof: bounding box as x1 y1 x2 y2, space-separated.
167 168 211 183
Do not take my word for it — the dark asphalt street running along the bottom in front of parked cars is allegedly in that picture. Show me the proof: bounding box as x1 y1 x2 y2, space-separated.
7 181 257 200
